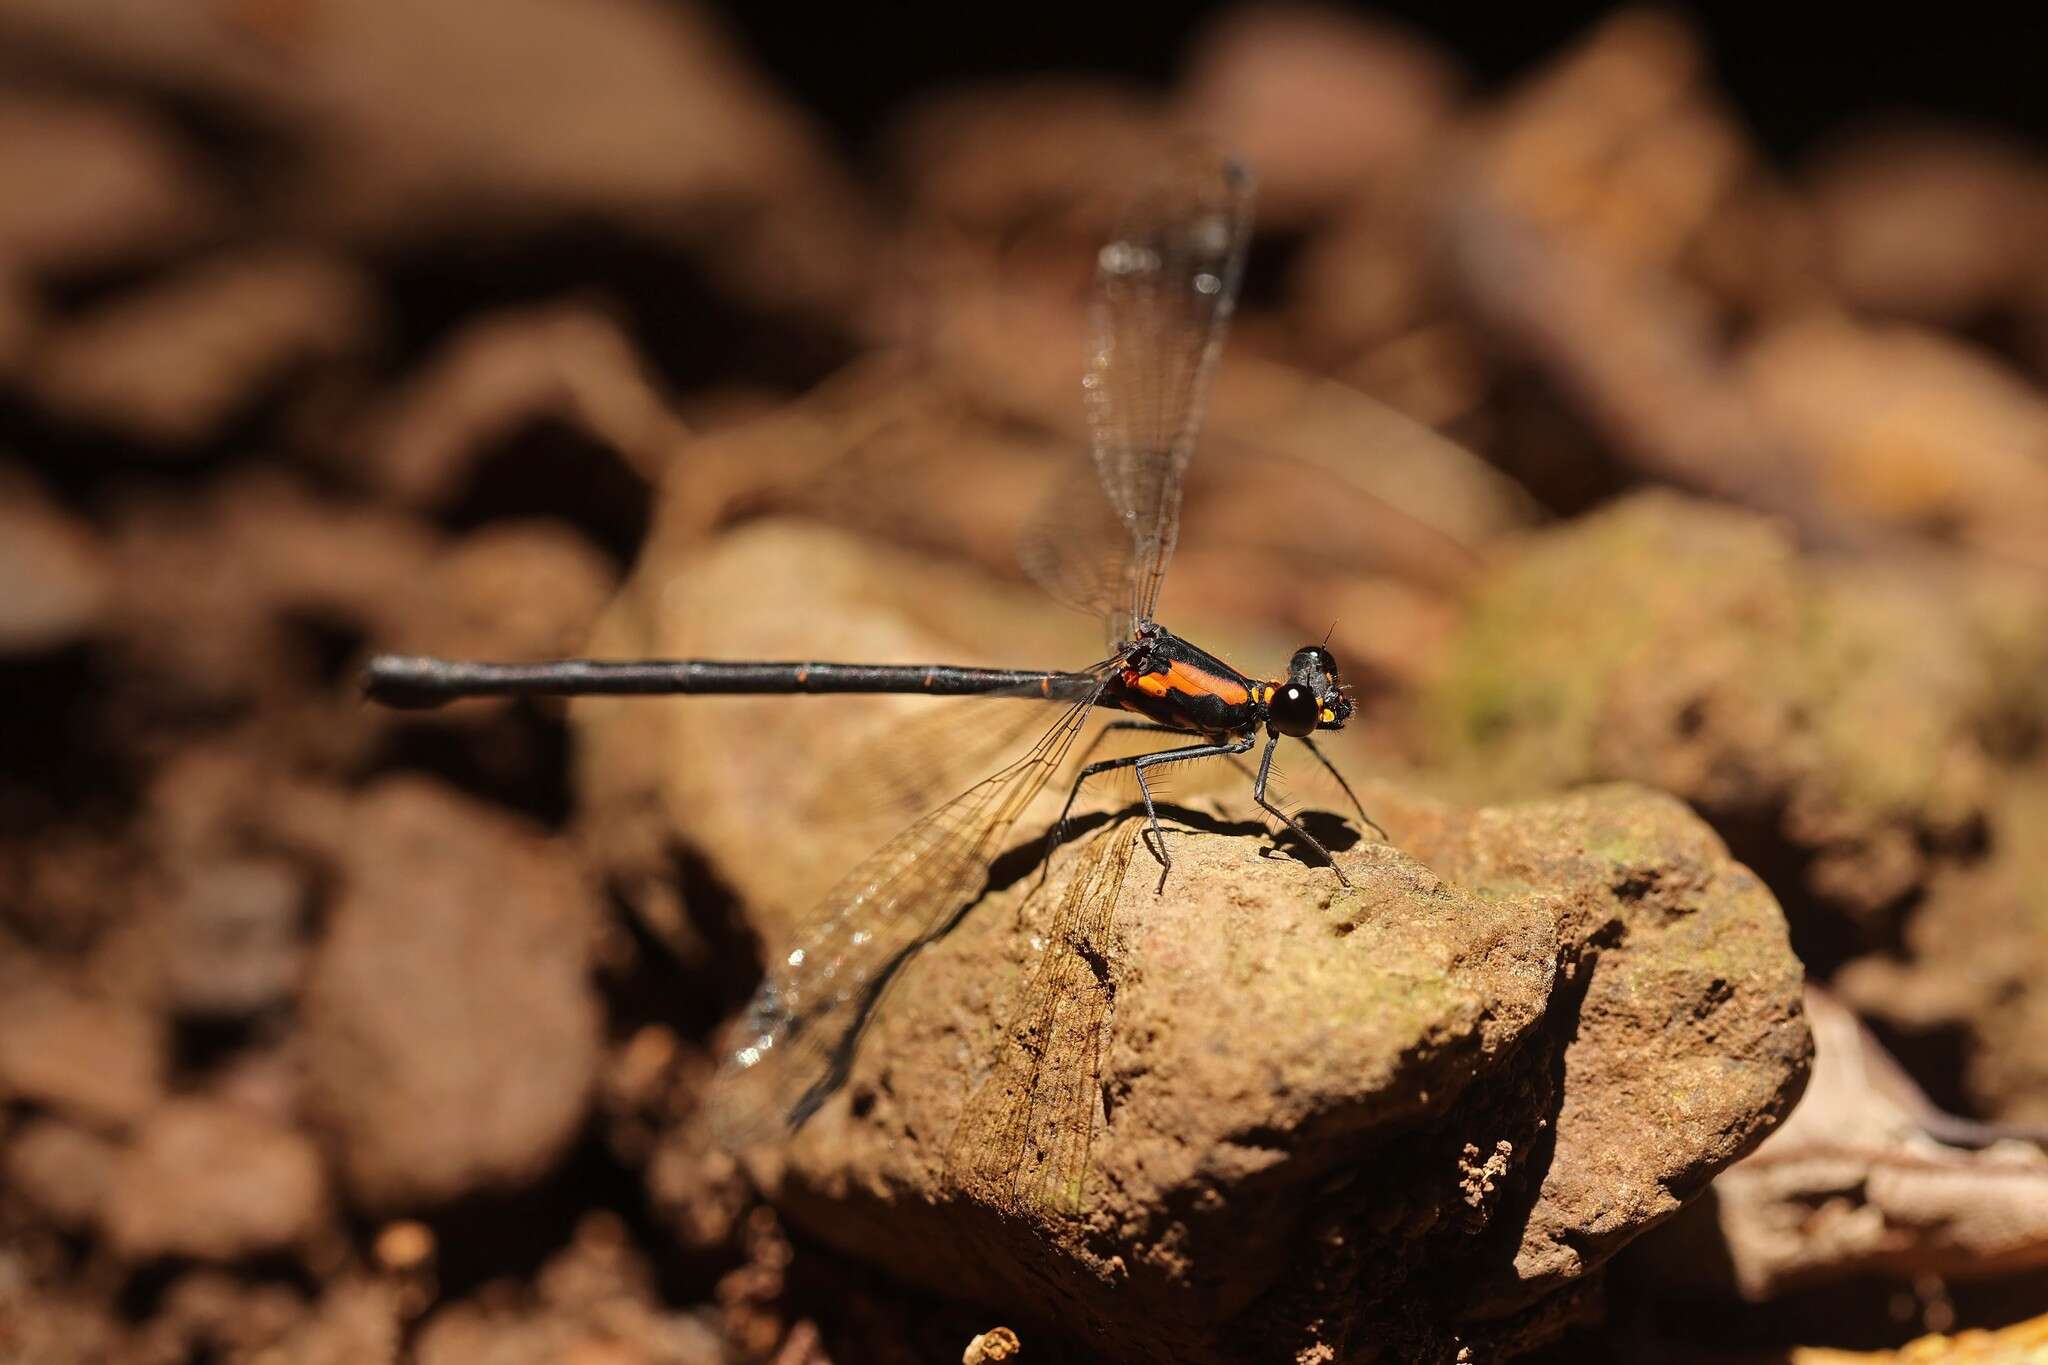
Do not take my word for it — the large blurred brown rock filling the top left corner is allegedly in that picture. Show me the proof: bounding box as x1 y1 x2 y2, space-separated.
0 0 872 315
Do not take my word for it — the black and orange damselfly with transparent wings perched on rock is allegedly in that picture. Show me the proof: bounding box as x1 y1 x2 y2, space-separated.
369 151 1384 1142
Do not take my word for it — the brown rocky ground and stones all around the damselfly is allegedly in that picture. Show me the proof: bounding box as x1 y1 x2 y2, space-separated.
0 0 2048 1365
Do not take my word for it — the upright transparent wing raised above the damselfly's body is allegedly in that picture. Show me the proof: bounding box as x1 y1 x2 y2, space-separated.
1081 151 1251 639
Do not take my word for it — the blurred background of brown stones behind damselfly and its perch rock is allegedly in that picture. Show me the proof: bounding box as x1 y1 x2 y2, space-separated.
0 0 2048 1363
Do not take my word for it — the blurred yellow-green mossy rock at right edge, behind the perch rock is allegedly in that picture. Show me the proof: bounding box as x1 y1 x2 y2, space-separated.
1423 493 2048 1121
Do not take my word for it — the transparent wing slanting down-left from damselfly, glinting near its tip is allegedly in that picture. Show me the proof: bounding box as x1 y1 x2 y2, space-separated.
711 667 1100 1148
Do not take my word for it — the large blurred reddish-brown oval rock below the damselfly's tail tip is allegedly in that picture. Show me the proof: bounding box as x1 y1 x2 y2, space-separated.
303 780 600 1209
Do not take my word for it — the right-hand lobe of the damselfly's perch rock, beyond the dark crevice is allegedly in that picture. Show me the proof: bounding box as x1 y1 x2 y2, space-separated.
1407 786 1812 1300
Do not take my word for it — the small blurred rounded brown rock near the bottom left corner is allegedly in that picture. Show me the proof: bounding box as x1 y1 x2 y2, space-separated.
100 1099 328 1261
